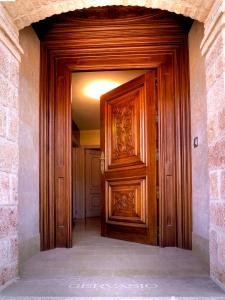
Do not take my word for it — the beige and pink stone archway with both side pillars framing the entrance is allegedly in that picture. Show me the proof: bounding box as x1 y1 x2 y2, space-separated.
0 0 225 288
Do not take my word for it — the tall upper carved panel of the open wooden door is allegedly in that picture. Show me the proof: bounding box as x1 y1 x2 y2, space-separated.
106 85 145 169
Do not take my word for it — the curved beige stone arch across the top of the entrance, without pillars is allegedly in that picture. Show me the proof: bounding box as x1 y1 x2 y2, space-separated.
4 0 214 29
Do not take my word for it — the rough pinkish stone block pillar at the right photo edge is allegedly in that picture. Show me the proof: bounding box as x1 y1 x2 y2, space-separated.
202 1 225 289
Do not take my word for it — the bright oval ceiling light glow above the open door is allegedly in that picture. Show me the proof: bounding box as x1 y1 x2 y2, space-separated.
83 79 121 100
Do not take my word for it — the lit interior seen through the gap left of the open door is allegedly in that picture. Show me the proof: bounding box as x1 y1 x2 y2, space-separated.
71 69 153 245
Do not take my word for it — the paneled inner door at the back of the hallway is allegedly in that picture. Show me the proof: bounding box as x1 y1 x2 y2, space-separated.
85 149 101 218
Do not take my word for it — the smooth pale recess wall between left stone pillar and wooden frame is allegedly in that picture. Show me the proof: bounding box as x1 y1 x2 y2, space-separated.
18 27 40 267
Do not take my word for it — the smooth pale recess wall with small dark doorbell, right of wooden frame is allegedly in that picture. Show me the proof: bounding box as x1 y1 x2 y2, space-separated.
189 21 209 262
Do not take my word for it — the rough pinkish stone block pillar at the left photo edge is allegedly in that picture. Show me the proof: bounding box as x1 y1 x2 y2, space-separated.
0 4 21 286
